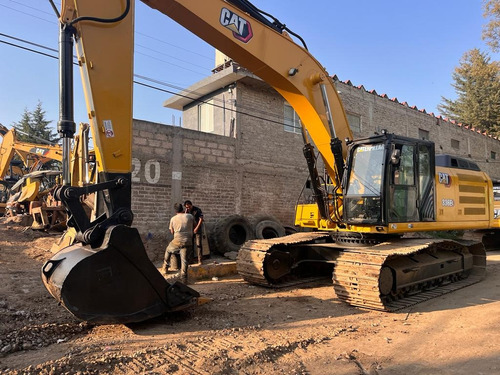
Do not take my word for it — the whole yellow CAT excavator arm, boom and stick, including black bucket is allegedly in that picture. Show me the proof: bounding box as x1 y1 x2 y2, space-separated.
42 0 352 323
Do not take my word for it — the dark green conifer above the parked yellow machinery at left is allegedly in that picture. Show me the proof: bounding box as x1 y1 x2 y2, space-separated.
14 102 58 143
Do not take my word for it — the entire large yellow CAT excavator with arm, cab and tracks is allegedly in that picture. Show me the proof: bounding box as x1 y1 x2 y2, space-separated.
42 0 492 323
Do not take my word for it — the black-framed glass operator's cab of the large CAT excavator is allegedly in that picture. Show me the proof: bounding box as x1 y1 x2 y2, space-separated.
344 134 435 226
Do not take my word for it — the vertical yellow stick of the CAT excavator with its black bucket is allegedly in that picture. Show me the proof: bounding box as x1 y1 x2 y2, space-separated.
41 0 199 323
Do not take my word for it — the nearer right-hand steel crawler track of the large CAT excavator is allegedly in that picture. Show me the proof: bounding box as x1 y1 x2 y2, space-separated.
333 238 486 311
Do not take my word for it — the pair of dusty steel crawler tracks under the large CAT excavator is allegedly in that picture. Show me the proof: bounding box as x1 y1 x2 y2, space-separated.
237 232 486 311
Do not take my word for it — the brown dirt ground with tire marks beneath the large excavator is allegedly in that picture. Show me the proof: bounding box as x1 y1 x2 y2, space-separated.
0 219 500 375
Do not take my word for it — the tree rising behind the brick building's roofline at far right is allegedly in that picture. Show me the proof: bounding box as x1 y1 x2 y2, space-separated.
438 48 500 135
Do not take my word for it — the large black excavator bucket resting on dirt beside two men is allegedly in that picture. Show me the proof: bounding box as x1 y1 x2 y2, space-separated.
42 225 200 323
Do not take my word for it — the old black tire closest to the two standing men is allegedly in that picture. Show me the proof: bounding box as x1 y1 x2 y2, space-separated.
211 215 254 254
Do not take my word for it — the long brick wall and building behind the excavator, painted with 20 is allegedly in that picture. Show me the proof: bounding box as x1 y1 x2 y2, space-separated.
132 77 500 244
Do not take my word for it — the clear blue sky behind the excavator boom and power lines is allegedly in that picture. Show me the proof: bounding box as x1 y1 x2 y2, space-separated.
0 0 500 137
